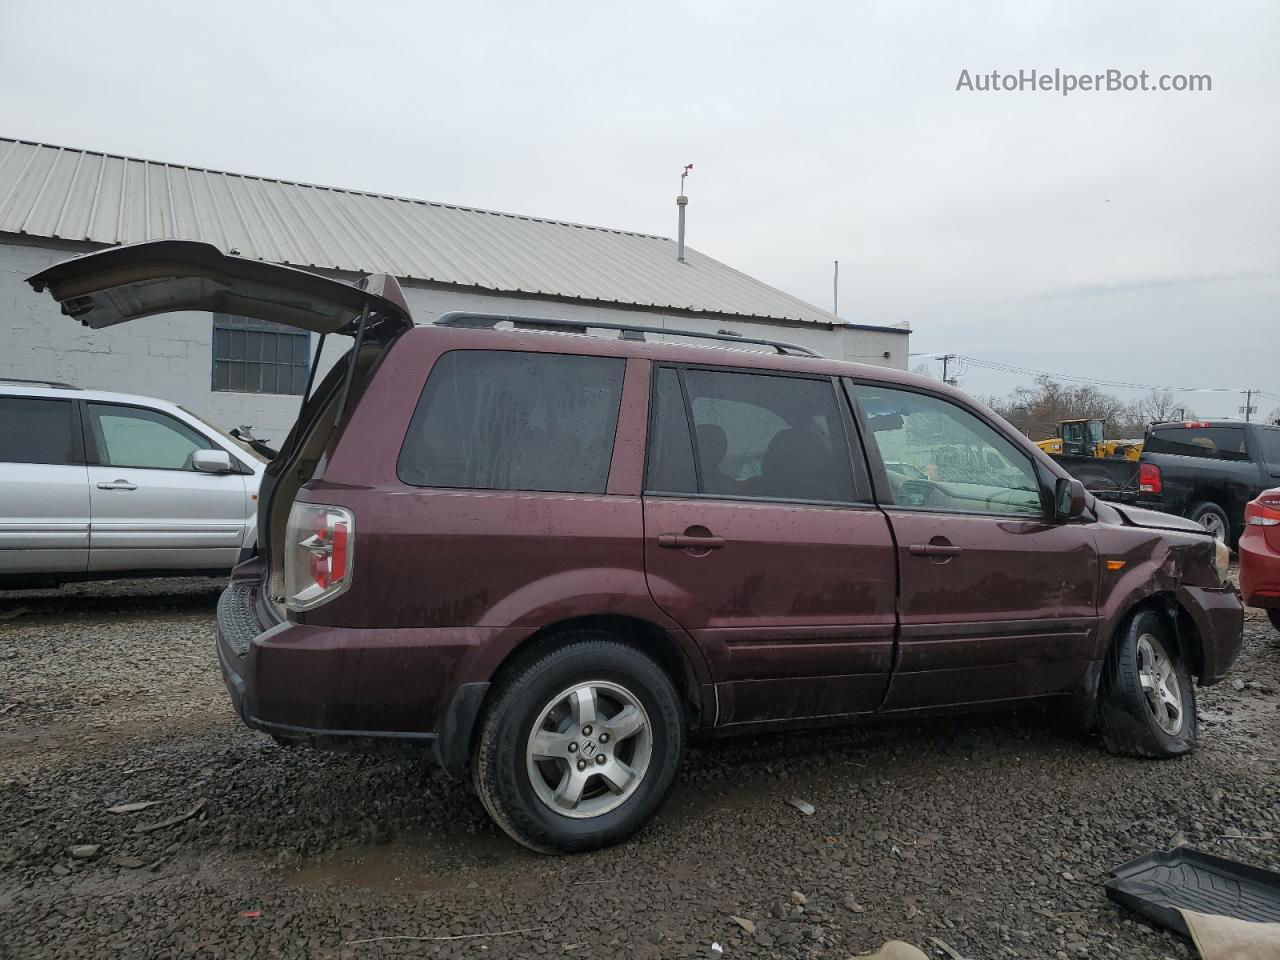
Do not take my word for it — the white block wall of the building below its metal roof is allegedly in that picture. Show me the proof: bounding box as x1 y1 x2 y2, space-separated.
0 236 909 440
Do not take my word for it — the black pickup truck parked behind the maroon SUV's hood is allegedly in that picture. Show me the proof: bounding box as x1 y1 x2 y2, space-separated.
1137 420 1280 545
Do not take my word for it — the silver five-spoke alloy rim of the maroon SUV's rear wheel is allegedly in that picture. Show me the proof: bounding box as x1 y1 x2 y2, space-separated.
525 680 653 819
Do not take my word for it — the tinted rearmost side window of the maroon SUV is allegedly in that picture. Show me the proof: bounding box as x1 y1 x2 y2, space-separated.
397 349 626 493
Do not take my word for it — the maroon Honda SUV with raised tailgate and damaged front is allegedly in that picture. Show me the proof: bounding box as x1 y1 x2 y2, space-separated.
31 241 1243 850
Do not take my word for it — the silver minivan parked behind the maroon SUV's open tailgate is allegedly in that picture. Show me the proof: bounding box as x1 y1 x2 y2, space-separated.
0 379 265 588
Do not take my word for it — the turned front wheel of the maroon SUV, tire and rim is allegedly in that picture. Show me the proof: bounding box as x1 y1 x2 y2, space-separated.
1098 609 1197 758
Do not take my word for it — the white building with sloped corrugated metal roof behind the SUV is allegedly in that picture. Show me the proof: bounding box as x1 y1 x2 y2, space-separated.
0 138 910 440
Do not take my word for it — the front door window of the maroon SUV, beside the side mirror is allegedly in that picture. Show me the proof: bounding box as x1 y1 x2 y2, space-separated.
854 385 1043 517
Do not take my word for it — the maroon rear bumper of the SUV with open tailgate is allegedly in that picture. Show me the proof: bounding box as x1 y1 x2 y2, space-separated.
218 579 489 776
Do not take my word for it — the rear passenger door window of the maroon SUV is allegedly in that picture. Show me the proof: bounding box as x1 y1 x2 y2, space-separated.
648 369 858 503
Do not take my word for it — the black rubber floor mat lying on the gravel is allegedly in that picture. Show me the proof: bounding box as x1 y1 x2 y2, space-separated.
1106 847 1280 936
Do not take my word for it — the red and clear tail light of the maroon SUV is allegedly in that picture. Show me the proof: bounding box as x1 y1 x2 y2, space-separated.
284 500 356 611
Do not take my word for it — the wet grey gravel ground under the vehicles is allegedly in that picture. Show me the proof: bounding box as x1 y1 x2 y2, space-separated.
0 580 1280 960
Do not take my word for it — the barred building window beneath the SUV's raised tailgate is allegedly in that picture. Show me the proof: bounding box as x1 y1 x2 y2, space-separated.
212 314 311 396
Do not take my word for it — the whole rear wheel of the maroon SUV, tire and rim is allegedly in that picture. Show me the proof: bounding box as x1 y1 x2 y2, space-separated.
471 631 685 854
